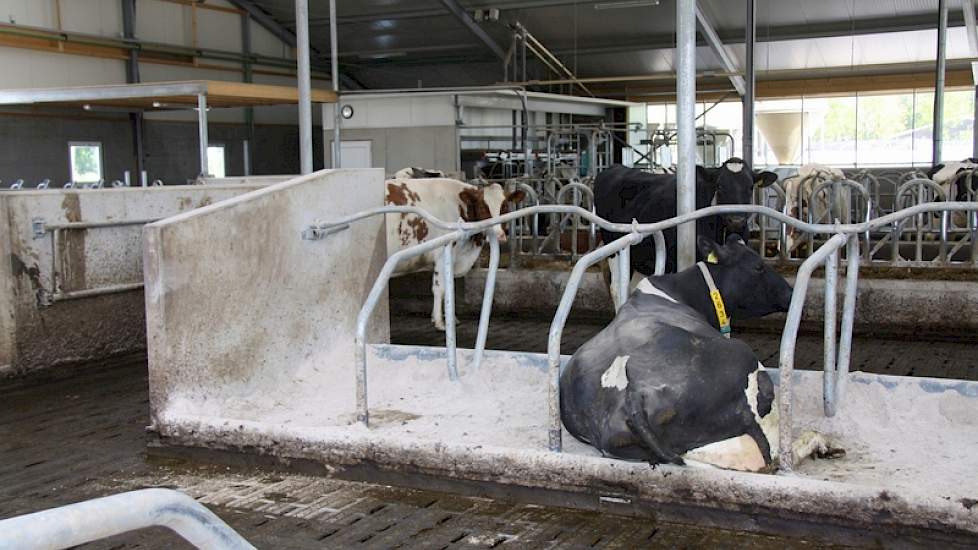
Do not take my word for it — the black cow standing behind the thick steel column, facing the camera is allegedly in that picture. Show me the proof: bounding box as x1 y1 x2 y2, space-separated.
594 161 778 275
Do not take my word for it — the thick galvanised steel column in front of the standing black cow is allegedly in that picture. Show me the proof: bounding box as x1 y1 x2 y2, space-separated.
676 0 696 270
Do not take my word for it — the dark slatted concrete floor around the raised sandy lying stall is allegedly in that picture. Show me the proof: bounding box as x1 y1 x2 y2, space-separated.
0 317 976 548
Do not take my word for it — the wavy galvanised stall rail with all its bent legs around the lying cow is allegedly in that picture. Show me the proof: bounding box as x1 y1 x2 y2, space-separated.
302 202 978 473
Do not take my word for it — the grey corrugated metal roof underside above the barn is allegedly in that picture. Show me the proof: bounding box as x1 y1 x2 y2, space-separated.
242 0 968 87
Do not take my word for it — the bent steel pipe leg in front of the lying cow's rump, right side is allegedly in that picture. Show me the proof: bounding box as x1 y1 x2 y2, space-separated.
778 233 849 474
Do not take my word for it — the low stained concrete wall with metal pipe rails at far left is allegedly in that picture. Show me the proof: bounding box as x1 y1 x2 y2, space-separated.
0 183 266 374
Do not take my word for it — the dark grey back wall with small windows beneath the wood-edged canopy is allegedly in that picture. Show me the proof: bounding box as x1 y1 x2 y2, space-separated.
0 114 323 187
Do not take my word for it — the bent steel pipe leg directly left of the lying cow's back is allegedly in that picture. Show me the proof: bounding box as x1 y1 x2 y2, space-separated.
547 233 643 453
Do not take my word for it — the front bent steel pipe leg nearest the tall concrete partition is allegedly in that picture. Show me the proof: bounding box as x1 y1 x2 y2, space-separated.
354 229 468 426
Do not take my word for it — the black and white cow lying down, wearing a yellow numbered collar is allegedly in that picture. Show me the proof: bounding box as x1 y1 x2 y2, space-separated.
560 235 841 472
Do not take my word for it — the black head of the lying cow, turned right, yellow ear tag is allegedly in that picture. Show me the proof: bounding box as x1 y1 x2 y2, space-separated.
697 235 791 320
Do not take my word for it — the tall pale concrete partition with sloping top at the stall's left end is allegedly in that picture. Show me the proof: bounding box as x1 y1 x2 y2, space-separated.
144 169 389 430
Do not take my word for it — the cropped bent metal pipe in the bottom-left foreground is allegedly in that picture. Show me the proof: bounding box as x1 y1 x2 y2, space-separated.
0 489 255 550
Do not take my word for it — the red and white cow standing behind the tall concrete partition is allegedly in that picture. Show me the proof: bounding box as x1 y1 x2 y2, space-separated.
386 178 523 330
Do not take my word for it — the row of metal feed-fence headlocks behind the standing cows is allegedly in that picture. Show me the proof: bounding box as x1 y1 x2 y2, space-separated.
462 169 978 269
